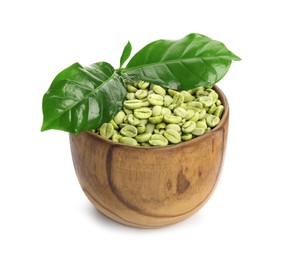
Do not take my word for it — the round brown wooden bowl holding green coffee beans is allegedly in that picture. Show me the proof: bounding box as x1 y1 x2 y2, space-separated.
70 87 229 228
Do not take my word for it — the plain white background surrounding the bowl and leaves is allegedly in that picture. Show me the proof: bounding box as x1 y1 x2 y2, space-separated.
0 0 285 260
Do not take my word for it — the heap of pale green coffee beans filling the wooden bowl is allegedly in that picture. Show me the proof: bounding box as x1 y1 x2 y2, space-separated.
97 78 224 146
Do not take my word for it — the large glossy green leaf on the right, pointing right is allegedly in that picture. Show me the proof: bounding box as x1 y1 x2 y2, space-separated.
123 34 240 90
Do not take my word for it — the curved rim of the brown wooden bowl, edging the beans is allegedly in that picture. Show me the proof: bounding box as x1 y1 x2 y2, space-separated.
83 85 229 150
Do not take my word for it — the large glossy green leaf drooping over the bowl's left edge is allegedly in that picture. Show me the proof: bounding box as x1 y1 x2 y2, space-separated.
41 62 126 134
